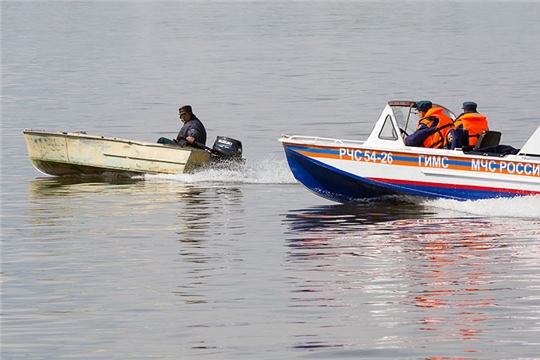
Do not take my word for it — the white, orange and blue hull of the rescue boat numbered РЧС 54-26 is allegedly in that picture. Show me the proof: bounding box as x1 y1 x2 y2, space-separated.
281 139 540 203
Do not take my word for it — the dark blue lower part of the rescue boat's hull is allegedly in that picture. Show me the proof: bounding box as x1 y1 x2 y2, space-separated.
285 146 520 203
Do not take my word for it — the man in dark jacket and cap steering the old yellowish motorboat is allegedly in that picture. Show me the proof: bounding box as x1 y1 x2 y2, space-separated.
158 105 206 147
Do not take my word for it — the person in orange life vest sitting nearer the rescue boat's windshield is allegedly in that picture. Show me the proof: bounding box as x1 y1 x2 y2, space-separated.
405 100 454 149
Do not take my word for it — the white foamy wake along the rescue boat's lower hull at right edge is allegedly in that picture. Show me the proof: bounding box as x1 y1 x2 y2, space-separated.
423 195 540 219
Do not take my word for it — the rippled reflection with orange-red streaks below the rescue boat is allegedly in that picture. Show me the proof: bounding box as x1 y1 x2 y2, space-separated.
283 204 540 356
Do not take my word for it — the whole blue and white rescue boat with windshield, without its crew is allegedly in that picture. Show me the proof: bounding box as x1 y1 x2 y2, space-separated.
279 101 540 203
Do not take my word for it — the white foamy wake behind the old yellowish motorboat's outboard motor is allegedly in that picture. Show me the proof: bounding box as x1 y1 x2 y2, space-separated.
142 158 297 184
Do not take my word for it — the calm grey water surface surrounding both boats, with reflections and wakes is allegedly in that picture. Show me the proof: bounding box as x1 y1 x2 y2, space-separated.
1 2 540 359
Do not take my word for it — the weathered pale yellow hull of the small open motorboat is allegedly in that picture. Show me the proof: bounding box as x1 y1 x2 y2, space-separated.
23 130 211 176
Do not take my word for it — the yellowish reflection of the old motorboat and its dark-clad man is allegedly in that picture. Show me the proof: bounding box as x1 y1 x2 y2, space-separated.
26 177 246 303
